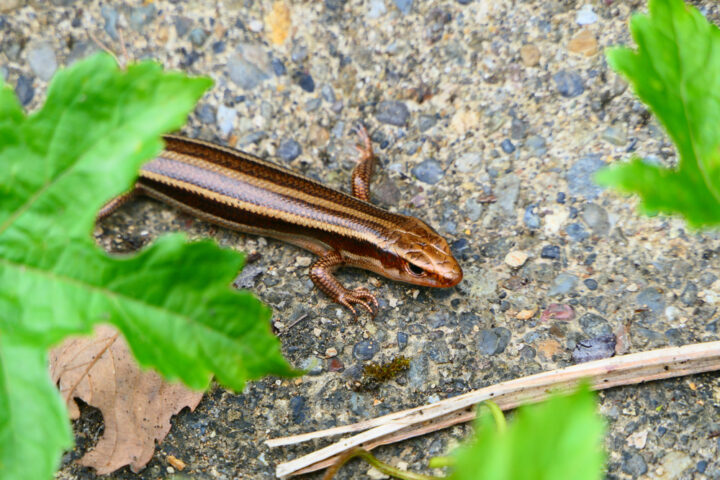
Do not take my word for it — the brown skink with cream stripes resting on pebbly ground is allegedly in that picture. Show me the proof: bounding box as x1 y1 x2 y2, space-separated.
98 127 462 315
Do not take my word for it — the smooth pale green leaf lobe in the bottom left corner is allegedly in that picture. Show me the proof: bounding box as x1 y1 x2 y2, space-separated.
0 337 73 480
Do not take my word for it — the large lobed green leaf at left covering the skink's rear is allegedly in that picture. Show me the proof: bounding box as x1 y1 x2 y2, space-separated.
0 55 297 479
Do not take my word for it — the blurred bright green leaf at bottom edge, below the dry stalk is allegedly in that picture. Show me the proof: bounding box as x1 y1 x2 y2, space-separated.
449 387 605 480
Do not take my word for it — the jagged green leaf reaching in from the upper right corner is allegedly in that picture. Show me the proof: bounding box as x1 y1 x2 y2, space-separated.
596 0 720 226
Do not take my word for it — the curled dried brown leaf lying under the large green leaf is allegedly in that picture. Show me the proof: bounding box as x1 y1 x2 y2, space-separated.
50 325 203 475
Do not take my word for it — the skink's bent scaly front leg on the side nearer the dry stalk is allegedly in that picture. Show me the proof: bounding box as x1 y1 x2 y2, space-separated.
310 250 380 317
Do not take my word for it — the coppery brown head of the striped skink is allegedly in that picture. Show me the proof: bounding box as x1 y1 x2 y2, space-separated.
385 217 463 288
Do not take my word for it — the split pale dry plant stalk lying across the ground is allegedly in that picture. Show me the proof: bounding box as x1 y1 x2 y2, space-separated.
266 341 720 477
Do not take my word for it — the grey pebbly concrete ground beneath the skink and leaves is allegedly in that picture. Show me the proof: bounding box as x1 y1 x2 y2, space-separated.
0 0 720 479
